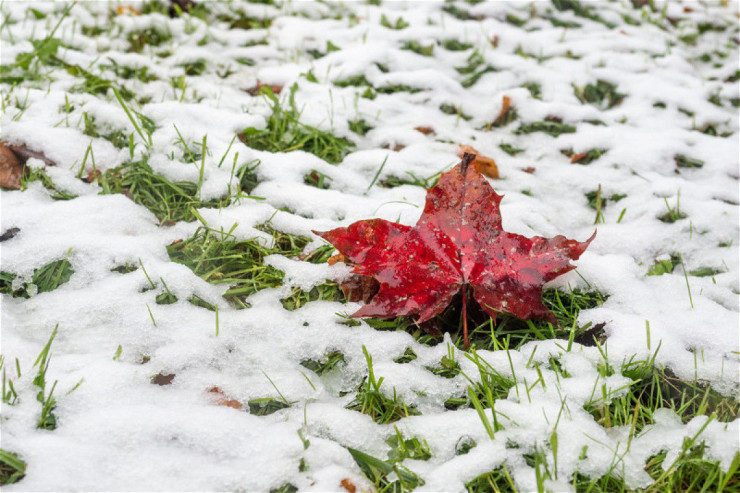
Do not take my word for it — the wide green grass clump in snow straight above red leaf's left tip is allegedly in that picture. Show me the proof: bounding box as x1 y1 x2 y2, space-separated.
239 85 354 164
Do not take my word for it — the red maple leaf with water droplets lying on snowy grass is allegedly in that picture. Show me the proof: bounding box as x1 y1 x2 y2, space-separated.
314 154 596 348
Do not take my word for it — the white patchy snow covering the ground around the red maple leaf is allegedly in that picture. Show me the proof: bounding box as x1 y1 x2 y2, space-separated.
0 0 740 491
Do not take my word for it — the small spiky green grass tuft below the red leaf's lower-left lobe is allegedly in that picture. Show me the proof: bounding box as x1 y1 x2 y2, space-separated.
347 346 421 424
